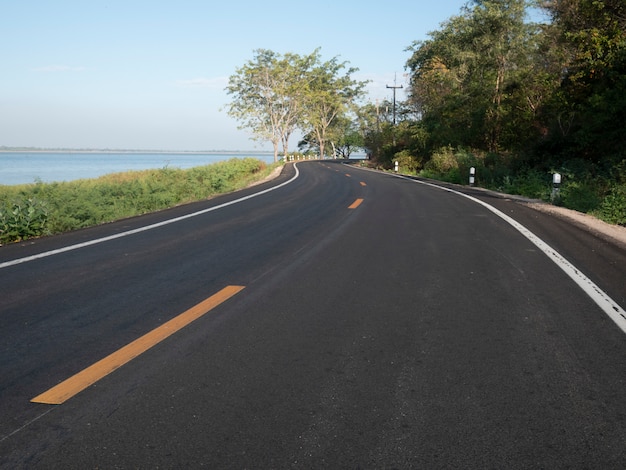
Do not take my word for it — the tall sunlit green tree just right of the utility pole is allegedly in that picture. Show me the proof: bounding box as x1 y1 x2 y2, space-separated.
407 0 538 151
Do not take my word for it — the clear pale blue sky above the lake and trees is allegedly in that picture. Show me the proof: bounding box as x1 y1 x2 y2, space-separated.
0 0 466 150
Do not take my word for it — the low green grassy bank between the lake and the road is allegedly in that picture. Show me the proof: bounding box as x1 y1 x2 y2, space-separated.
0 158 277 244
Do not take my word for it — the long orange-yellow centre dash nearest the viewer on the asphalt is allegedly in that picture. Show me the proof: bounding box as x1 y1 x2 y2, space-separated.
31 286 244 405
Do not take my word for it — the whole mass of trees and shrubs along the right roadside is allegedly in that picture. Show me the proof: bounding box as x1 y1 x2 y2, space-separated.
358 0 626 225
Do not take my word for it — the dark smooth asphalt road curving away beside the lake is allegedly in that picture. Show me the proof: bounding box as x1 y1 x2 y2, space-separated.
0 162 626 469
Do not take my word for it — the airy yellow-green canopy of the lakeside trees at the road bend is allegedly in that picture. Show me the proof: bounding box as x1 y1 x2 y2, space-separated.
226 49 365 159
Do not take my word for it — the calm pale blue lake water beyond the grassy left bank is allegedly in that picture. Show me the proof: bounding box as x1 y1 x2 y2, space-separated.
0 152 274 185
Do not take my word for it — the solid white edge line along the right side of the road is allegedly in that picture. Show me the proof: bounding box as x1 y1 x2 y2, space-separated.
354 167 626 333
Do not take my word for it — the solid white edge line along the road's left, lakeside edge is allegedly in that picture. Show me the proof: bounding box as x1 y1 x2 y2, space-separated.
0 163 300 269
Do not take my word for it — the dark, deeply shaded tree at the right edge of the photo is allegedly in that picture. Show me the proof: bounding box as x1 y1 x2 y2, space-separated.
542 0 626 163
